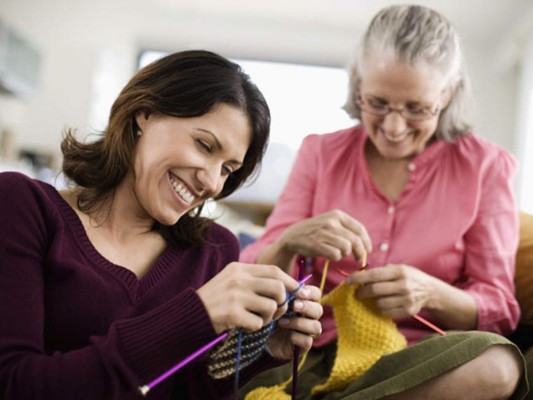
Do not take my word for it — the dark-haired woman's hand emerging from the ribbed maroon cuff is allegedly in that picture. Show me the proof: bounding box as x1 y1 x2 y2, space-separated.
196 262 299 333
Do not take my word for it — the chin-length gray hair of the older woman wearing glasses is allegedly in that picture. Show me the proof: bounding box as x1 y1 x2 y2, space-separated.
344 5 470 142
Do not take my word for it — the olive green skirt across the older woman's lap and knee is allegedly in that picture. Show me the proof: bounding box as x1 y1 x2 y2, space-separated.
239 331 533 400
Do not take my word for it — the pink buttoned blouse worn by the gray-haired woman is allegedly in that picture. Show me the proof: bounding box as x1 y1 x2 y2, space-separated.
240 126 520 346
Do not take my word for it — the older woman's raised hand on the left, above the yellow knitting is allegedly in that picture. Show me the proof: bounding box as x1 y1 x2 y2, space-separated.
277 210 372 261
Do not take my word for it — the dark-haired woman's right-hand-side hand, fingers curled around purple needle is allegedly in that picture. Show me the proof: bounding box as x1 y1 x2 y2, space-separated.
268 285 323 360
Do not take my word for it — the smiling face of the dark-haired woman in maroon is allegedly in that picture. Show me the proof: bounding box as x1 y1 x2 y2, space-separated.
131 104 252 225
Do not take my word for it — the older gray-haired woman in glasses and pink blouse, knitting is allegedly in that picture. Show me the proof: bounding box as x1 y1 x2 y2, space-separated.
240 5 528 400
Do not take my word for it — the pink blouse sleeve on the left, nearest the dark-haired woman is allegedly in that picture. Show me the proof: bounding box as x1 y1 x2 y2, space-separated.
240 135 320 263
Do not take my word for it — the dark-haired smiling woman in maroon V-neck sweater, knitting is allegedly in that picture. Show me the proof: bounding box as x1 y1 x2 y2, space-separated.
0 51 322 400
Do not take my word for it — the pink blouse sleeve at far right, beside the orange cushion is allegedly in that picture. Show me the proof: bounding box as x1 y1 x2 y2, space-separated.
461 149 520 335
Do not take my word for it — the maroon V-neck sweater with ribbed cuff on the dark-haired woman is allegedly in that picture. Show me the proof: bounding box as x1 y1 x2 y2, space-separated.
0 172 278 400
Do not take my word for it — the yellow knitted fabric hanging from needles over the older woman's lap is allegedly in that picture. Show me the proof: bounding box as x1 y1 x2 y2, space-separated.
312 283 407 394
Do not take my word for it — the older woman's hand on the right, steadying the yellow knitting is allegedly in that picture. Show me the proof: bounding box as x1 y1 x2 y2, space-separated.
346 264 436 318
